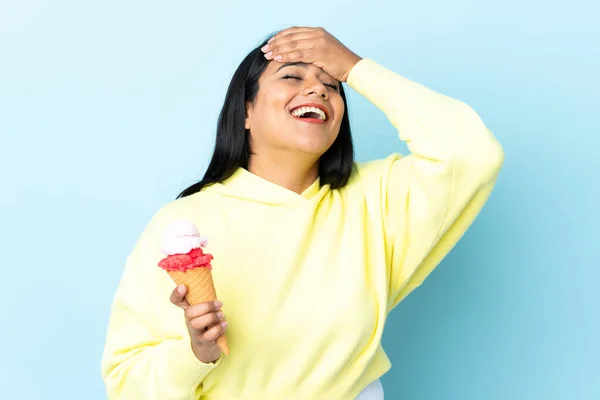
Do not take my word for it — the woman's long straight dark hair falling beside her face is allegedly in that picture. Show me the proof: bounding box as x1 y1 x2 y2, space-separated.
177 36 354 198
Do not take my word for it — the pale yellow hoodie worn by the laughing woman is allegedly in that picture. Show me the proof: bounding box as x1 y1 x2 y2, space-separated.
102 59 503 400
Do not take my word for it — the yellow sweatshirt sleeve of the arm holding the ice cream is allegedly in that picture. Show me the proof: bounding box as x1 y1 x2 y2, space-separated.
101 211 221 400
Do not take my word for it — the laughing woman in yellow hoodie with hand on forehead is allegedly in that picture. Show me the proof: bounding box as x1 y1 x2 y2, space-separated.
102 27 503 400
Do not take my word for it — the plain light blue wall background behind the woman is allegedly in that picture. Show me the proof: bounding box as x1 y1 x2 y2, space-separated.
0 0 600 400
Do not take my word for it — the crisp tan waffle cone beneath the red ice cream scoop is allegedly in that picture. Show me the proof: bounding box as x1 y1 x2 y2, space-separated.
167 268 229 355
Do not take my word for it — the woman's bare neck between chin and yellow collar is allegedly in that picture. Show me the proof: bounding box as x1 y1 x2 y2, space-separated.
248 154 319 194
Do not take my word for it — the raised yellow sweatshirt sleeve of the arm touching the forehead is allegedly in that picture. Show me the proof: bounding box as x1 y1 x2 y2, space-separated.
348 59 504 310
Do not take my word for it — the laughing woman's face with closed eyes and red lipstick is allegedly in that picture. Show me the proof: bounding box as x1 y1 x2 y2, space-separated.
246 61 345 157
